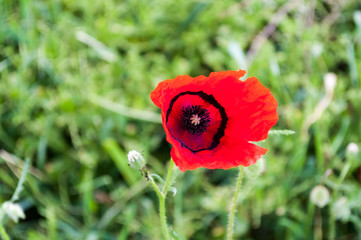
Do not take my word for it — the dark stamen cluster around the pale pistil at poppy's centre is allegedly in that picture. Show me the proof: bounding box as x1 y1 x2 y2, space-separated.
182 105 211 136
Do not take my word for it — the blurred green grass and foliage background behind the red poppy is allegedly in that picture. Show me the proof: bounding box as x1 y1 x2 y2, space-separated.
0 0 361 240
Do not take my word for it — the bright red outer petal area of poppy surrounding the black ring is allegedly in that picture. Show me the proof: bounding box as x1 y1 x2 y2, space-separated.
151 70 278 171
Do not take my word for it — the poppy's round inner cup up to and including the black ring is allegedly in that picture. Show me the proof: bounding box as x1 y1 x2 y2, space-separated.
165 91 228 153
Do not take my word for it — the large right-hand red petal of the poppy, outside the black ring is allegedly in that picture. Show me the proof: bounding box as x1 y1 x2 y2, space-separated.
208 76 278 142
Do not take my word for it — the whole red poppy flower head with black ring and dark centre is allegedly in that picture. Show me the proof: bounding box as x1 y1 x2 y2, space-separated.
150 70 278 171
